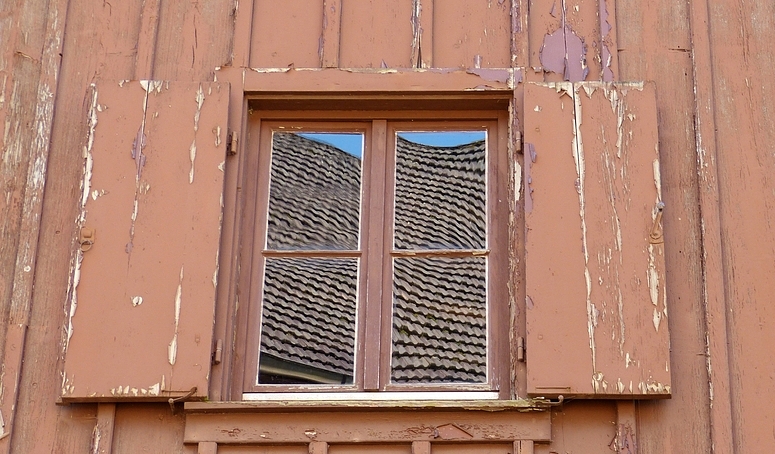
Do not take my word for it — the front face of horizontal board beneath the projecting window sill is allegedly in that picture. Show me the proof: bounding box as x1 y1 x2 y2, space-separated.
184 410 551 444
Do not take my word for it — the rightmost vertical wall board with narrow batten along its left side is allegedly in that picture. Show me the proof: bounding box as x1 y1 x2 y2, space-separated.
708 0 775 452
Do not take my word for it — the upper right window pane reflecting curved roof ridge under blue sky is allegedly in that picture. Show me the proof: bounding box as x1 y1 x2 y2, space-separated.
394 131 487 249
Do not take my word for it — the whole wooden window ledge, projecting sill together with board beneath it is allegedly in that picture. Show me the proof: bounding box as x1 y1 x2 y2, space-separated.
184 400 551 446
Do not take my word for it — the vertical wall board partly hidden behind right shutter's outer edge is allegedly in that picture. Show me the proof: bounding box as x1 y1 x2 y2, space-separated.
616 0 712 453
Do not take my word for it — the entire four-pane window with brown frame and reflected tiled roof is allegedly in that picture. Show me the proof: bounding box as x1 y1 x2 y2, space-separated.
242 112 509 398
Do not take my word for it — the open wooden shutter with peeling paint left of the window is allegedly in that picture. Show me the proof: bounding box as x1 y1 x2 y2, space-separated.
62 81 229 401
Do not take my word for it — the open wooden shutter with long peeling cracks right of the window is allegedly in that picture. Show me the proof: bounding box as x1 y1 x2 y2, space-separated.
524 82 670 398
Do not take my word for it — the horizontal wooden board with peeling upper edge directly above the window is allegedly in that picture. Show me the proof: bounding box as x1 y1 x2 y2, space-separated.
224 68 514 95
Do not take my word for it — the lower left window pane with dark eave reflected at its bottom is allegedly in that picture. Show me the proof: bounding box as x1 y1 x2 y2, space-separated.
258 258 358 384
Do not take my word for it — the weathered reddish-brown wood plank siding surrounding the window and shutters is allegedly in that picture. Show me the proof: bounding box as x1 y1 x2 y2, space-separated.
0 0 775 454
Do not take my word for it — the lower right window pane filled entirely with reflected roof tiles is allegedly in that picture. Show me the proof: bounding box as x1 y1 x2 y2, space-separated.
391 257 487 383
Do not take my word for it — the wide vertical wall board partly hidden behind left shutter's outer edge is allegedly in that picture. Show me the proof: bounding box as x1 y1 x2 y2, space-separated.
11 1 140 452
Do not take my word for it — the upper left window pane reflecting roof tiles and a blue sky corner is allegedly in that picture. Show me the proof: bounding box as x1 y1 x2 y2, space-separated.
266 132 363 250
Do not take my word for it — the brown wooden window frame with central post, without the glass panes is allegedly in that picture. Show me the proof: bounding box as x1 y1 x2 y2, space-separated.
232 109 512 399
